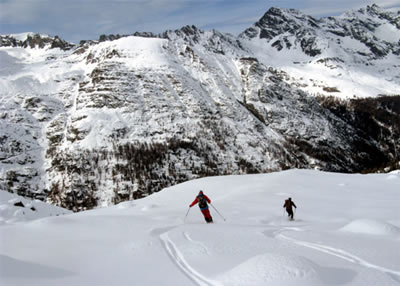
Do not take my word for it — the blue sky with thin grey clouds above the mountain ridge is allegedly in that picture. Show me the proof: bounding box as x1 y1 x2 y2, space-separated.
0 0 400 43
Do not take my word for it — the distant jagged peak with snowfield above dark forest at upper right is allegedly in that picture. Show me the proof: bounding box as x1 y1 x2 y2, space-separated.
241 5 400 99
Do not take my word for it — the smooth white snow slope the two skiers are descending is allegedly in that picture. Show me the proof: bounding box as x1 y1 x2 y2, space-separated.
0 170 400 286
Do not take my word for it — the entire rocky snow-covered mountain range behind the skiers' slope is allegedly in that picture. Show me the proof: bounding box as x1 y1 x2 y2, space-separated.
0 5 400 210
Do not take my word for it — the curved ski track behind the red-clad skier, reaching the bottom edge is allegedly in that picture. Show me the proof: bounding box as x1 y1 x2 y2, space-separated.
160 232 222 286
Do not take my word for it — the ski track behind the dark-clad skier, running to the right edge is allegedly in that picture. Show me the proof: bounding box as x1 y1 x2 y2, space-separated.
276 230 400 280
